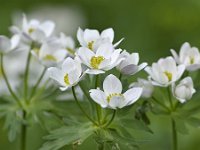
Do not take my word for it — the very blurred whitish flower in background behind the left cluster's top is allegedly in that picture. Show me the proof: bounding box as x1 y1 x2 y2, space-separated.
13 4 87 36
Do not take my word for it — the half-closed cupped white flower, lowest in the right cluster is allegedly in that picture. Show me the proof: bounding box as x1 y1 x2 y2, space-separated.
172 77 196 103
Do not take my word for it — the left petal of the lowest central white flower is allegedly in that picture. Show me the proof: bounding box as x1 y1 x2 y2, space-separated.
89 89 108 108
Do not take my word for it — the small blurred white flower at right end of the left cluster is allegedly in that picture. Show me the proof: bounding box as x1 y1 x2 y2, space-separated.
59 33 76 57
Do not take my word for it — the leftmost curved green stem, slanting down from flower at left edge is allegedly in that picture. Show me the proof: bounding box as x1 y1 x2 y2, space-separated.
1 54 22 107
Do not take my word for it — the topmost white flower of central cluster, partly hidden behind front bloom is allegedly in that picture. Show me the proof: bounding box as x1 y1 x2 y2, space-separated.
77 28 123 51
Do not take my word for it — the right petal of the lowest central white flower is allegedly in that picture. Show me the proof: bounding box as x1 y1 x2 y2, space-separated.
123 88 142 105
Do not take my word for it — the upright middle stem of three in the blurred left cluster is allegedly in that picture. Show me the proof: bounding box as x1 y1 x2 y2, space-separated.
24 51 31 100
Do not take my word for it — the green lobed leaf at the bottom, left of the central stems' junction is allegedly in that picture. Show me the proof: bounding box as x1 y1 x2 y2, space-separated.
40 123 95 150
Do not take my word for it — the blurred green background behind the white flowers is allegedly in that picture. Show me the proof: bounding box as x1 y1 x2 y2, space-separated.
0 0 200 150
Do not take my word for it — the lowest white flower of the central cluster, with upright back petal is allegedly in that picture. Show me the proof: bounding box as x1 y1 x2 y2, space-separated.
89 74 142 109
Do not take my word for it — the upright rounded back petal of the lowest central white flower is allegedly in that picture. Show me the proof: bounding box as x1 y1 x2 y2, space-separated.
103 74 122 95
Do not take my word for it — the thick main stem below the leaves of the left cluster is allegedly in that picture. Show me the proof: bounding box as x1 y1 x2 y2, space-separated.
21 111 27 150
